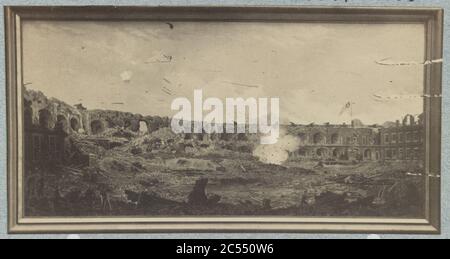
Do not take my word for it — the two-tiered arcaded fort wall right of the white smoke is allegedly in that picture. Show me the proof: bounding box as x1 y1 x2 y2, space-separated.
288 115 424 161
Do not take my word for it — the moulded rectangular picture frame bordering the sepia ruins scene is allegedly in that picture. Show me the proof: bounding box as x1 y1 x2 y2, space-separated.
5 6 443 234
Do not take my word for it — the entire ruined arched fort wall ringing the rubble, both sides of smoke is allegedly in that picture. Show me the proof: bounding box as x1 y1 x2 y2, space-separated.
25 91 424 161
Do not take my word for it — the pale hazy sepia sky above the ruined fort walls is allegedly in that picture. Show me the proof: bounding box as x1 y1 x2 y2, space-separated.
23 22 425 124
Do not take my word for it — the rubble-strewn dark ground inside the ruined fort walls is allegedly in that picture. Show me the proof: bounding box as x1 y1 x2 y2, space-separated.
26 129 425 218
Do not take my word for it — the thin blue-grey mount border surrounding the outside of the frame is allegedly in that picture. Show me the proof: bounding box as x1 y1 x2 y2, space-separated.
0 0 450 239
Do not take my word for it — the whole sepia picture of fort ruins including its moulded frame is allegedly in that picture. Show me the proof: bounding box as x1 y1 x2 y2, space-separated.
5 6 443 234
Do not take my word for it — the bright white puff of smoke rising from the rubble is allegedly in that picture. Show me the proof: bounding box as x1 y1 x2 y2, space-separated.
253 130 301 165
